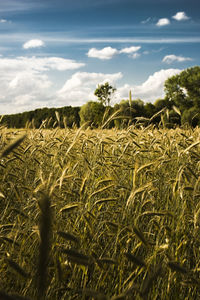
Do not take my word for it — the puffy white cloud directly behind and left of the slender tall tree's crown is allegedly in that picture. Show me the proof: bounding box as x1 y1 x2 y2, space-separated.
57 72 123 105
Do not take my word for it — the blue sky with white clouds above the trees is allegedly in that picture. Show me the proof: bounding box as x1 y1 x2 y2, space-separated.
0 0 200 114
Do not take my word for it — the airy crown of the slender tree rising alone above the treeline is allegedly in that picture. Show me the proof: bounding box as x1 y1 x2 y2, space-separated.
94 82 116 106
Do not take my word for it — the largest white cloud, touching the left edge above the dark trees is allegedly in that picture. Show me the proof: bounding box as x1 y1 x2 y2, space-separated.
0 57 84 113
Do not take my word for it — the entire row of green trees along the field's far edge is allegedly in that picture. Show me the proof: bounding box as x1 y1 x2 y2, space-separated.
2 66 200 129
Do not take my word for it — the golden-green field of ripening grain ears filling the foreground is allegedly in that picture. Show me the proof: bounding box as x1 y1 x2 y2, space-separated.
0 127 200 300
